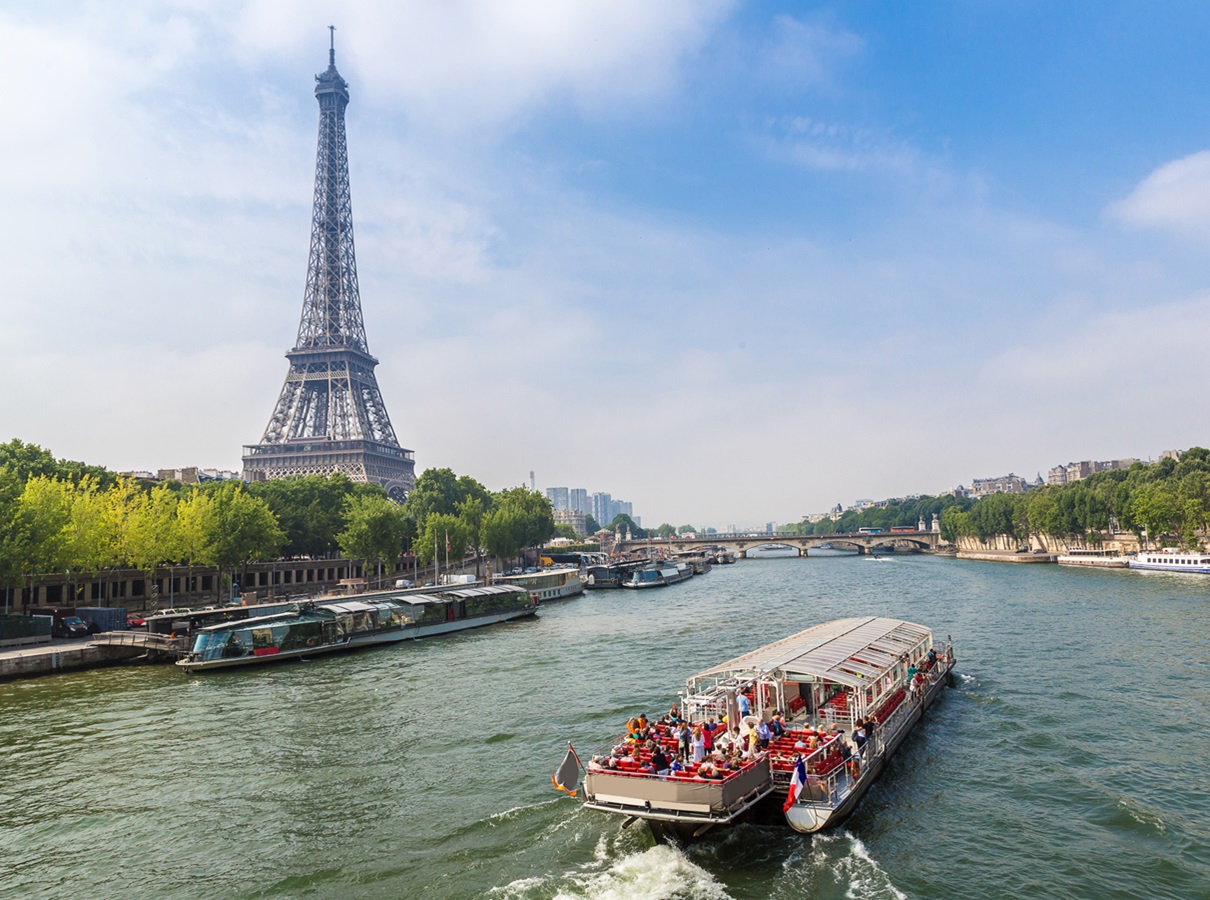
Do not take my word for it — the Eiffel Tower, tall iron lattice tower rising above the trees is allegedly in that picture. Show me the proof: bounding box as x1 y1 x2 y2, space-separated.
243 28 415 502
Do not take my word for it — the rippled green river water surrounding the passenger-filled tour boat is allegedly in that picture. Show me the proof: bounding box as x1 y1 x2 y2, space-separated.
0 556 1210 900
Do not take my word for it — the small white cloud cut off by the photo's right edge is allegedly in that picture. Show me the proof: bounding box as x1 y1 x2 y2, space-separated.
1108 150 1210 238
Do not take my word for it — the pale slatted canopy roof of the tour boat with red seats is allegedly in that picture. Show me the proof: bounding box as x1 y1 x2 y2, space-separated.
688 616 933 690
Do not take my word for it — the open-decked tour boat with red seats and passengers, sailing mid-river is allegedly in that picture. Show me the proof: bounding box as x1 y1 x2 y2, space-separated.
566 616 953 837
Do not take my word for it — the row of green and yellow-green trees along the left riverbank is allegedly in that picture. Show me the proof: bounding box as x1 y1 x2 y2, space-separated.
0 439 554 590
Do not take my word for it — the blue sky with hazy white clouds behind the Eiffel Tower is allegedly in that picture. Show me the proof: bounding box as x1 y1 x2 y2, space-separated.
0 0 1210 527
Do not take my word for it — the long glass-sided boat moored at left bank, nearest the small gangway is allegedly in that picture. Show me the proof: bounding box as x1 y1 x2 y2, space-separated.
177 584 537 673
